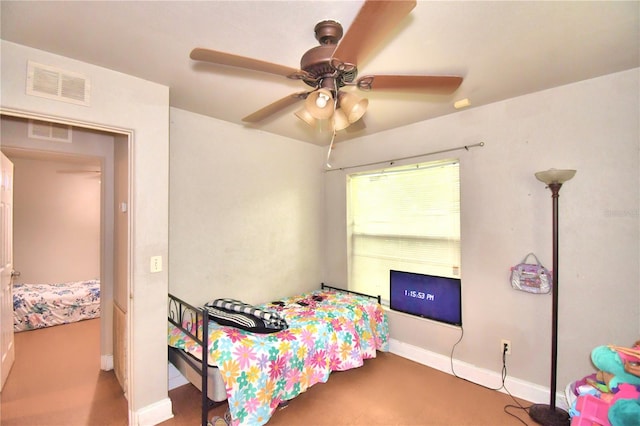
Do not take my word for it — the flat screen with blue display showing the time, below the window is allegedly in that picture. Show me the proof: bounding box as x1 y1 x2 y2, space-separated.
390 270 462 326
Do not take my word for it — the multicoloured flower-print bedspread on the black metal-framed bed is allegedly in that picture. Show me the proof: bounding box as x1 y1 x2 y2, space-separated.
169 290 389 426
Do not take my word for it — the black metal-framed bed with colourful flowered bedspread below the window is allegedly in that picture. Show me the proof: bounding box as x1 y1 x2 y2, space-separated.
168 285 389 425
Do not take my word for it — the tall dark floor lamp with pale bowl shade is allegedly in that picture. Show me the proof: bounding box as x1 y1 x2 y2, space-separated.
529 169 576 426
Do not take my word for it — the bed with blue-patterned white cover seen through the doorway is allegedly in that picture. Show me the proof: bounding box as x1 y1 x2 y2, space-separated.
13 280 100 332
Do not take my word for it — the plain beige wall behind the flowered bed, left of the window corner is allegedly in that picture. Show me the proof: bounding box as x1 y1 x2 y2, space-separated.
169 108 324 304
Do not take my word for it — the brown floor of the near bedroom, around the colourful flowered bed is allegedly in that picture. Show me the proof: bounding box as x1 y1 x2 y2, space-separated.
162 353 535 426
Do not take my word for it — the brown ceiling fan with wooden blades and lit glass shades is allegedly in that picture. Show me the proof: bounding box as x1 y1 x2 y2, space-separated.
190 0 462 134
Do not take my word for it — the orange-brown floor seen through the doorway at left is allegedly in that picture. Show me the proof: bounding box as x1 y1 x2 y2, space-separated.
0 319 128 426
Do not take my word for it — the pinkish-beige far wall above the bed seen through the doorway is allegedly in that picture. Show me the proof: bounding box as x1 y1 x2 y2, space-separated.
10 157 100 283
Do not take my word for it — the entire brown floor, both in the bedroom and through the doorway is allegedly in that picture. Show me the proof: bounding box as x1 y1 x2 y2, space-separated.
0 319 534 426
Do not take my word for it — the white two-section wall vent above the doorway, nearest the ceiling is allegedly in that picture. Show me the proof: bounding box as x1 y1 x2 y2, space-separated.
27 61 90 106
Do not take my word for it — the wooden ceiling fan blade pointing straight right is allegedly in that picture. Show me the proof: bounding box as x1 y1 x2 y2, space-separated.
356 75 462 95
